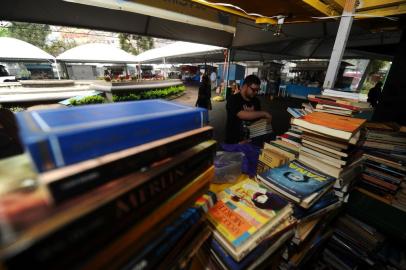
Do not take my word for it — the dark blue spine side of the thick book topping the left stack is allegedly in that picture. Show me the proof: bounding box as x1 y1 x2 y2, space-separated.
28 111 207 172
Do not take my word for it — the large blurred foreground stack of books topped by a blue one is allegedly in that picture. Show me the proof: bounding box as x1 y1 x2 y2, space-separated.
0 100 216 269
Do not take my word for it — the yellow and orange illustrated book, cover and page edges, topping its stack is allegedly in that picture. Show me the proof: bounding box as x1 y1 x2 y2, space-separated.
208 179 292 261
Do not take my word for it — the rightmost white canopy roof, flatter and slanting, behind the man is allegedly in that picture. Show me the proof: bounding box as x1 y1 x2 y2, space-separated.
136 41 224 63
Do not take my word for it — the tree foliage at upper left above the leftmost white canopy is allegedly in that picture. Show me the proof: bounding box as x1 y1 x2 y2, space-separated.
8 22 51 49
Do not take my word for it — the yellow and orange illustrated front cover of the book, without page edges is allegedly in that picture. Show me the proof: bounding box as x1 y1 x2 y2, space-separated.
208 179 291 248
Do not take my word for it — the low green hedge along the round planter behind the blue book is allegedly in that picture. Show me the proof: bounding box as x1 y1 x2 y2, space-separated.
113 85 186 102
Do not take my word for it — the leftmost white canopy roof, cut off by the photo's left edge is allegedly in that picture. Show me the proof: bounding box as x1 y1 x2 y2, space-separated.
0 37 55 60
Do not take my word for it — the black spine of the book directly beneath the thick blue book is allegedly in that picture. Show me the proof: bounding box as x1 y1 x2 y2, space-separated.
48 129 212 203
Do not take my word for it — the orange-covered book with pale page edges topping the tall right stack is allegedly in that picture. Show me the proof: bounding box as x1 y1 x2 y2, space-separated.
292 112 366 141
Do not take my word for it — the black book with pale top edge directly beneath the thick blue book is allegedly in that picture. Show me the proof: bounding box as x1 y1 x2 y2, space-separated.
38 126 213 203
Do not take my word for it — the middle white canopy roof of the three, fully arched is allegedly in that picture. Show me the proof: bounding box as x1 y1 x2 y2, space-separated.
56 43 137 63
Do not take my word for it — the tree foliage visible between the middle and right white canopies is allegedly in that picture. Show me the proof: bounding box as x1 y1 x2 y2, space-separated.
118 33 154 55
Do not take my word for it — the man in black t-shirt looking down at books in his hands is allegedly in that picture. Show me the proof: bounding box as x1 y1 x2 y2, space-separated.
225 75 272 144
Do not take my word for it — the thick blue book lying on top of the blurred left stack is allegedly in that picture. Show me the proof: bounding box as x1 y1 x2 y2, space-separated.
16 100 208 172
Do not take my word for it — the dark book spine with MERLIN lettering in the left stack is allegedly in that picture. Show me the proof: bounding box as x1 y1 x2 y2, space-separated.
4 144 216 269
